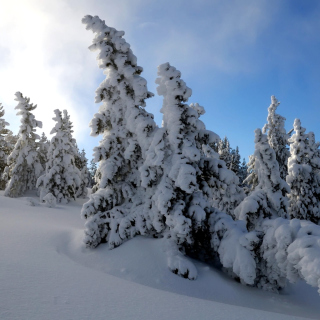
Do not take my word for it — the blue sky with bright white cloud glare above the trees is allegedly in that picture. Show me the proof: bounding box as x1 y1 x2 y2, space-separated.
0 0 320 158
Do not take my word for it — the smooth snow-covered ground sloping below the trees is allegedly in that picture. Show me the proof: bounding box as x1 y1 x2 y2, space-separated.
0 192 320 320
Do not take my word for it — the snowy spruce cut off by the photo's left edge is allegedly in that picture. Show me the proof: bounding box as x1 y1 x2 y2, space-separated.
0 103 11 190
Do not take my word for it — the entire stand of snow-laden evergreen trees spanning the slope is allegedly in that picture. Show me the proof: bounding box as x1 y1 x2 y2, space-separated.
0 16 320 292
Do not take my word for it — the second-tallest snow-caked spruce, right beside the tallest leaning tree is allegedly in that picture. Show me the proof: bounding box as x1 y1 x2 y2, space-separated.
140 63 210 279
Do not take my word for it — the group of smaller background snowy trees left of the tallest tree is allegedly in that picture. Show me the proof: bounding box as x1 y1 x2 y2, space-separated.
0 92 96 203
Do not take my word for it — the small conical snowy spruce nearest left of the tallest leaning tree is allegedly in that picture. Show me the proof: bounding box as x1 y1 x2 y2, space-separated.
37 109 81 203
